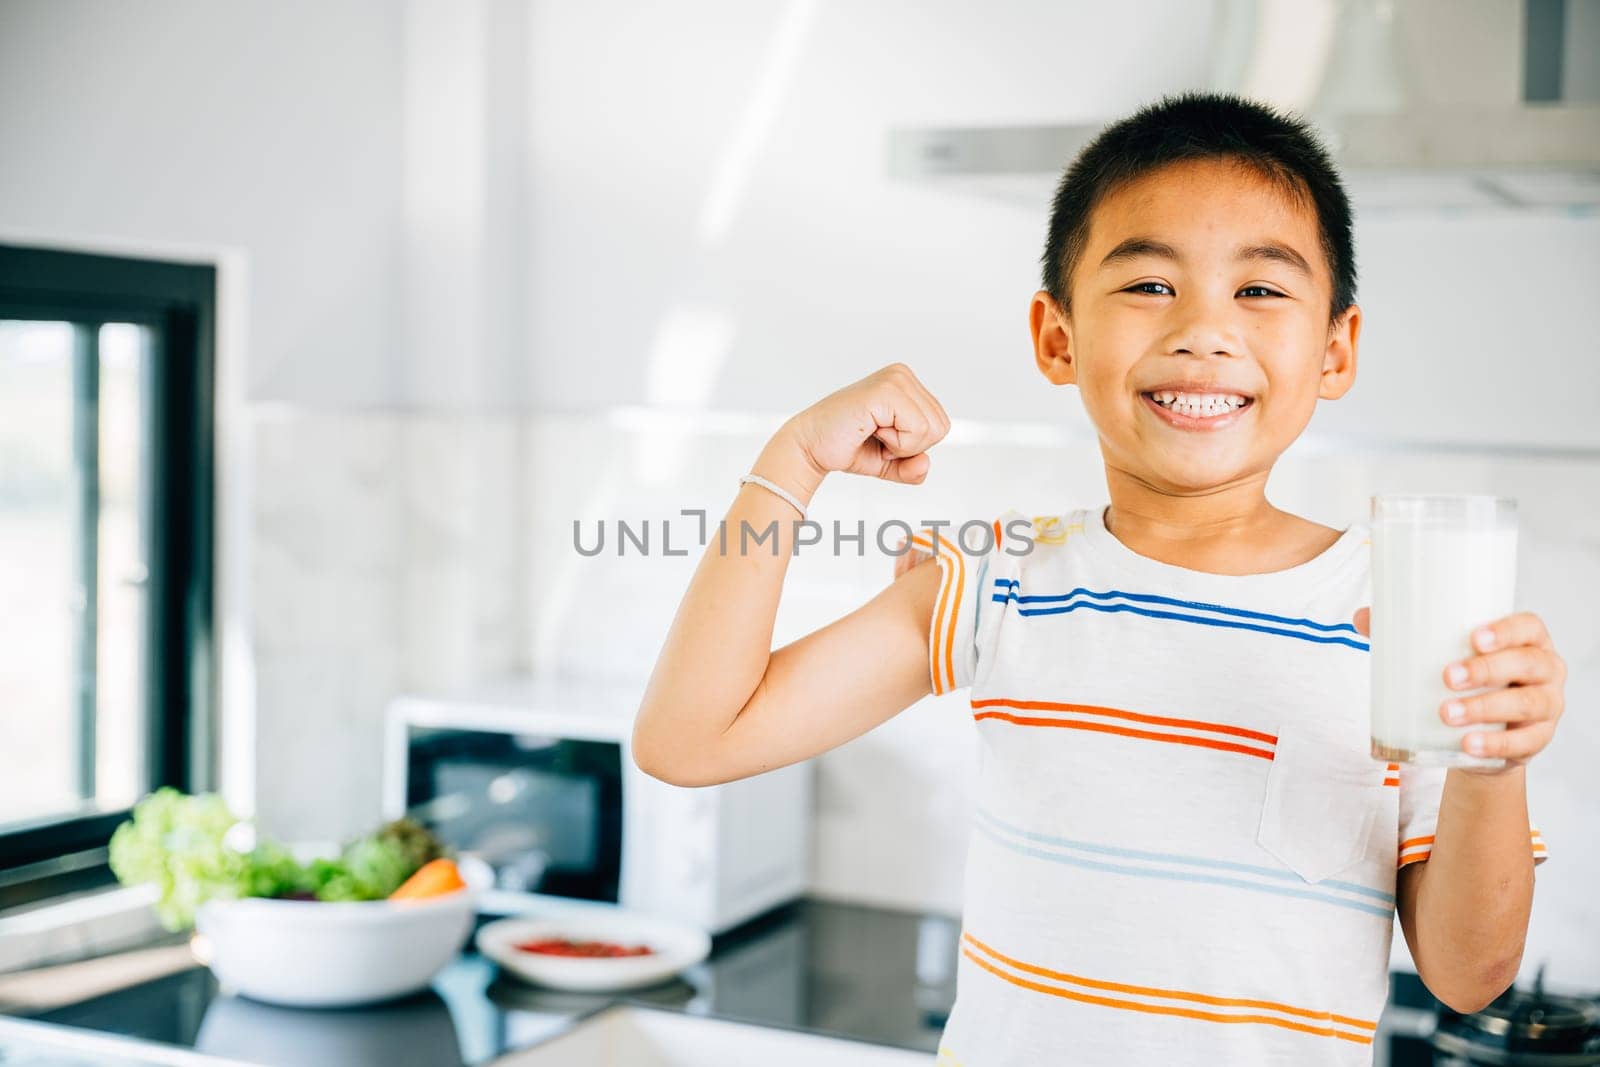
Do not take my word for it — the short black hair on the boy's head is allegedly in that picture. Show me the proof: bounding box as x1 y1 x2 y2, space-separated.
1042 91 1355 322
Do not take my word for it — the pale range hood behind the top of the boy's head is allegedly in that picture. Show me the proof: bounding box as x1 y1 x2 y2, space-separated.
890 0 1600 218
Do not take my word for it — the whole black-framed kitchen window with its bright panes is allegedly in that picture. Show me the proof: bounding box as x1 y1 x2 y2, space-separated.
0 245 216 910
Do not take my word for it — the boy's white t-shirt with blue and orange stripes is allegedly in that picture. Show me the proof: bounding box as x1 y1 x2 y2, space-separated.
914 507 1544 1067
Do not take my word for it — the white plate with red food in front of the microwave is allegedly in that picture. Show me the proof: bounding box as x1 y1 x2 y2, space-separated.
477 912 710 993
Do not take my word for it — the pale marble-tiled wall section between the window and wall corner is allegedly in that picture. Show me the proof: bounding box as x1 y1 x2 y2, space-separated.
250 411 528 840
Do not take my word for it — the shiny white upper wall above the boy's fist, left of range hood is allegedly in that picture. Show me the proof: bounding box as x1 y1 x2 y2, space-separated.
526 0 1208 416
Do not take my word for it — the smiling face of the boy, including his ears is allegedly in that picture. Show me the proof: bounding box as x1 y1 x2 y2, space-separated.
1029 160 1360 494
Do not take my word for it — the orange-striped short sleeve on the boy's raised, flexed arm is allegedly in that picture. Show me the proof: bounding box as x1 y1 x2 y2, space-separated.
912 509 1032 694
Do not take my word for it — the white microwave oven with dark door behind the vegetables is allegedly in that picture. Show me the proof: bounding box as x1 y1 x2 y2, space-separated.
382 680 813 934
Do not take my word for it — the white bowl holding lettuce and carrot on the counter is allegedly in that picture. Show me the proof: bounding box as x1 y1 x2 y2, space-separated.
195 886 477 1008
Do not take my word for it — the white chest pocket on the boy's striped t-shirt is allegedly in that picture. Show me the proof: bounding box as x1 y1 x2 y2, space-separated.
1256 728 1382 881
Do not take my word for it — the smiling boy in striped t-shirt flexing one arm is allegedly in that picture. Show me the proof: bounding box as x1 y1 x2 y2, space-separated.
634 94 1566 1067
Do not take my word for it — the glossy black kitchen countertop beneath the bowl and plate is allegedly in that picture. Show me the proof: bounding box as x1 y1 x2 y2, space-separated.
0 899 960 1067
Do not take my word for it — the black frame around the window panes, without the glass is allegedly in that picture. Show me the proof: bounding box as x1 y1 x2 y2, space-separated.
0 243 218 910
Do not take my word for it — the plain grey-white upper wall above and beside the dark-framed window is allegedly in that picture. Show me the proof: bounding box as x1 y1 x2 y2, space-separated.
0 0 402 406
